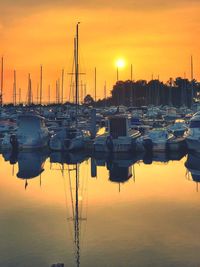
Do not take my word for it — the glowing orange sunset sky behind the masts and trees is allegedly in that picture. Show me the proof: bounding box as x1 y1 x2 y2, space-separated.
0 0 200 101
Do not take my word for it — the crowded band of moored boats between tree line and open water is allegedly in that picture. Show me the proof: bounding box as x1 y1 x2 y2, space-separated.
0 104 197 155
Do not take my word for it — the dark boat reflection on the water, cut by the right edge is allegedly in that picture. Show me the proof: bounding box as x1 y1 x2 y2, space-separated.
185 151 200 192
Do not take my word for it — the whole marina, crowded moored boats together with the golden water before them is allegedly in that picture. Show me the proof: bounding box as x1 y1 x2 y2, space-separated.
0 101 200 267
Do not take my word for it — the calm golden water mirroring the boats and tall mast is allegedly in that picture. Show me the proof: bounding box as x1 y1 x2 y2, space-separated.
0 152 200 267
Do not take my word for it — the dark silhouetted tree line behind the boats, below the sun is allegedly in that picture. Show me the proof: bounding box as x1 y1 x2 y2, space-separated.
85 77 200 107
